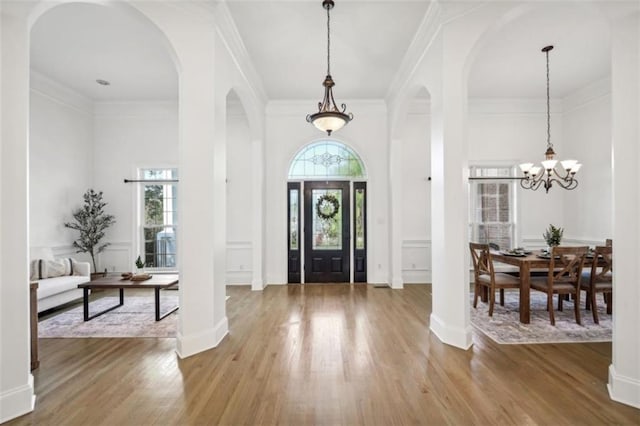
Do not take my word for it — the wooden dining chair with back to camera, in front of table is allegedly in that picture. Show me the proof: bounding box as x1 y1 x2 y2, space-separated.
530 246 589 325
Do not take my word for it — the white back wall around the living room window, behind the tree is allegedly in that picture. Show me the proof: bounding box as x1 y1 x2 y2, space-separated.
93 102 180 271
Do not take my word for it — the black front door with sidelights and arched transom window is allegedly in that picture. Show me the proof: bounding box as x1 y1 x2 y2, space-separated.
287 140 367 283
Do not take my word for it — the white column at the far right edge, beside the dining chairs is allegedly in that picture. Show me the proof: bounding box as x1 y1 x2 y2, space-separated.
608 13 640 408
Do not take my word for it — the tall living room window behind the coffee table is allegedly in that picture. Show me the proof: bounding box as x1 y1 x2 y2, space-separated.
140 169 178 269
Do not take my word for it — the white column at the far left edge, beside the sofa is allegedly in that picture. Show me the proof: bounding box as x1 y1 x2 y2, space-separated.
0 3 35 423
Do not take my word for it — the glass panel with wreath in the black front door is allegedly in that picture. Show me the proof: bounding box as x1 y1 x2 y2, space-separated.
311 189 342 250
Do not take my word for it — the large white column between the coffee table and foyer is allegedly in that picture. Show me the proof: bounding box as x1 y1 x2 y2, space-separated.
176 40 228 358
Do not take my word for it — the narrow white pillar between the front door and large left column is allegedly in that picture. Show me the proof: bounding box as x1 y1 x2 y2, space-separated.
251 140 265 290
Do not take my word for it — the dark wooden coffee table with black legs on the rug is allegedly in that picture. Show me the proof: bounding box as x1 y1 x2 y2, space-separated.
78 274 178 321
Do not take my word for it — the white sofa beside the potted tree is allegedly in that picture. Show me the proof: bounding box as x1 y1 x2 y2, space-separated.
30 247 91 312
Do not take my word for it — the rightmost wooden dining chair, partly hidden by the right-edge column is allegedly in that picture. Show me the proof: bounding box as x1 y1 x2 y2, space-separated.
580 246 613 324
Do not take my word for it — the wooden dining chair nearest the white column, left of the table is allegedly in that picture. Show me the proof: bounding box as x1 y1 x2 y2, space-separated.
469 243 520 317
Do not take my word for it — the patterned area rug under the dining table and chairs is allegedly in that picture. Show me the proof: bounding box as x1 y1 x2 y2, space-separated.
471 290 612 344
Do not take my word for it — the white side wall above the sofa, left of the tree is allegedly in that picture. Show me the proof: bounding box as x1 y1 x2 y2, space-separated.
29 73 93 258
